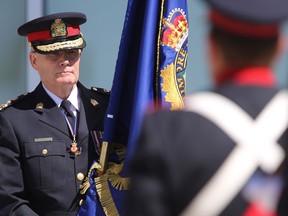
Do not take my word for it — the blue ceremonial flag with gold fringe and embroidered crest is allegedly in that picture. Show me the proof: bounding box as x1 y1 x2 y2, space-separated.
78 0 188 216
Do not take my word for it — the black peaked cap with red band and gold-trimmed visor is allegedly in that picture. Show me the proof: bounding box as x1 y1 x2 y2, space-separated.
18 12 86 54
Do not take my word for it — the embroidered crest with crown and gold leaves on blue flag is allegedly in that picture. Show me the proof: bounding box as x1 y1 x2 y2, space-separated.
160 8 189 110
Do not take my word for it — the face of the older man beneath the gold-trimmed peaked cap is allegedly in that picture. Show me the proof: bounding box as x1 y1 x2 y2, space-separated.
30 49 81 91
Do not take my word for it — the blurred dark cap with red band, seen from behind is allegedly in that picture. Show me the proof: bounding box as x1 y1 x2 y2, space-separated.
205 0 288 37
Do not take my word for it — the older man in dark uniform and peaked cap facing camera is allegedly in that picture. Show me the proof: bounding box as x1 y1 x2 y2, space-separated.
0 12 109 216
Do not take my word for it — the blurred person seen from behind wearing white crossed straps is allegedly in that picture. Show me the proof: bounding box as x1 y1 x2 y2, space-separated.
127 0 288 216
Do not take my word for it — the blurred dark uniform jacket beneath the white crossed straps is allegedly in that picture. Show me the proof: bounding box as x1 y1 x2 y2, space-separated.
127 80 288 216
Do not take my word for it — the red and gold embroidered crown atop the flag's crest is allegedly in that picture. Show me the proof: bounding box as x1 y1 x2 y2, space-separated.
162 9 188 51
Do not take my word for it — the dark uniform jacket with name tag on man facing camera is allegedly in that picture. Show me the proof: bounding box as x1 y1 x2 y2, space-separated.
0 83 109 216
